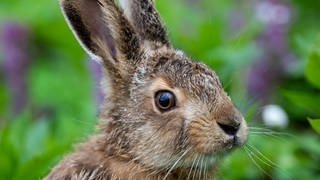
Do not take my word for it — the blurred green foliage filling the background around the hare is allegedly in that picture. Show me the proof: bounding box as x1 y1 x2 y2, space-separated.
0 0 320 179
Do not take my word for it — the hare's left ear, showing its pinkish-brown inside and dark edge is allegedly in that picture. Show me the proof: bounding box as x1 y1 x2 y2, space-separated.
60 0 140 73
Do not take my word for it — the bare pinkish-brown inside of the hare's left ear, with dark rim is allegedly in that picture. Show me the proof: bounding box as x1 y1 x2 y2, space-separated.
61 0 116 59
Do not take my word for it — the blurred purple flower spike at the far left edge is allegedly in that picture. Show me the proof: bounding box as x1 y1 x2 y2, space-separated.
0 22 29 114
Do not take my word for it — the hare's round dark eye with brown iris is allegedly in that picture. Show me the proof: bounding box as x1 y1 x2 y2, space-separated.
155 91 176 111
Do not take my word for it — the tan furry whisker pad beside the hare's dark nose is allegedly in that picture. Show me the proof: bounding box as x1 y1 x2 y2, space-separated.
188 119 228 154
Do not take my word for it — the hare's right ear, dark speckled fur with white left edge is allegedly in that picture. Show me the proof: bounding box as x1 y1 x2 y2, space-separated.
120 0 171 47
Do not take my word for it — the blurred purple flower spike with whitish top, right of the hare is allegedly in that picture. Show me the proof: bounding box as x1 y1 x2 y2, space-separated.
248 0 292 103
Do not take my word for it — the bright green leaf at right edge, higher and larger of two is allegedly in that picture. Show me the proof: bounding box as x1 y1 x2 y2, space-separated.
306 51 320 89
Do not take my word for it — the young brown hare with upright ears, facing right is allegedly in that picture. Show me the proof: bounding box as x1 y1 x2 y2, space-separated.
47 0 248 179
